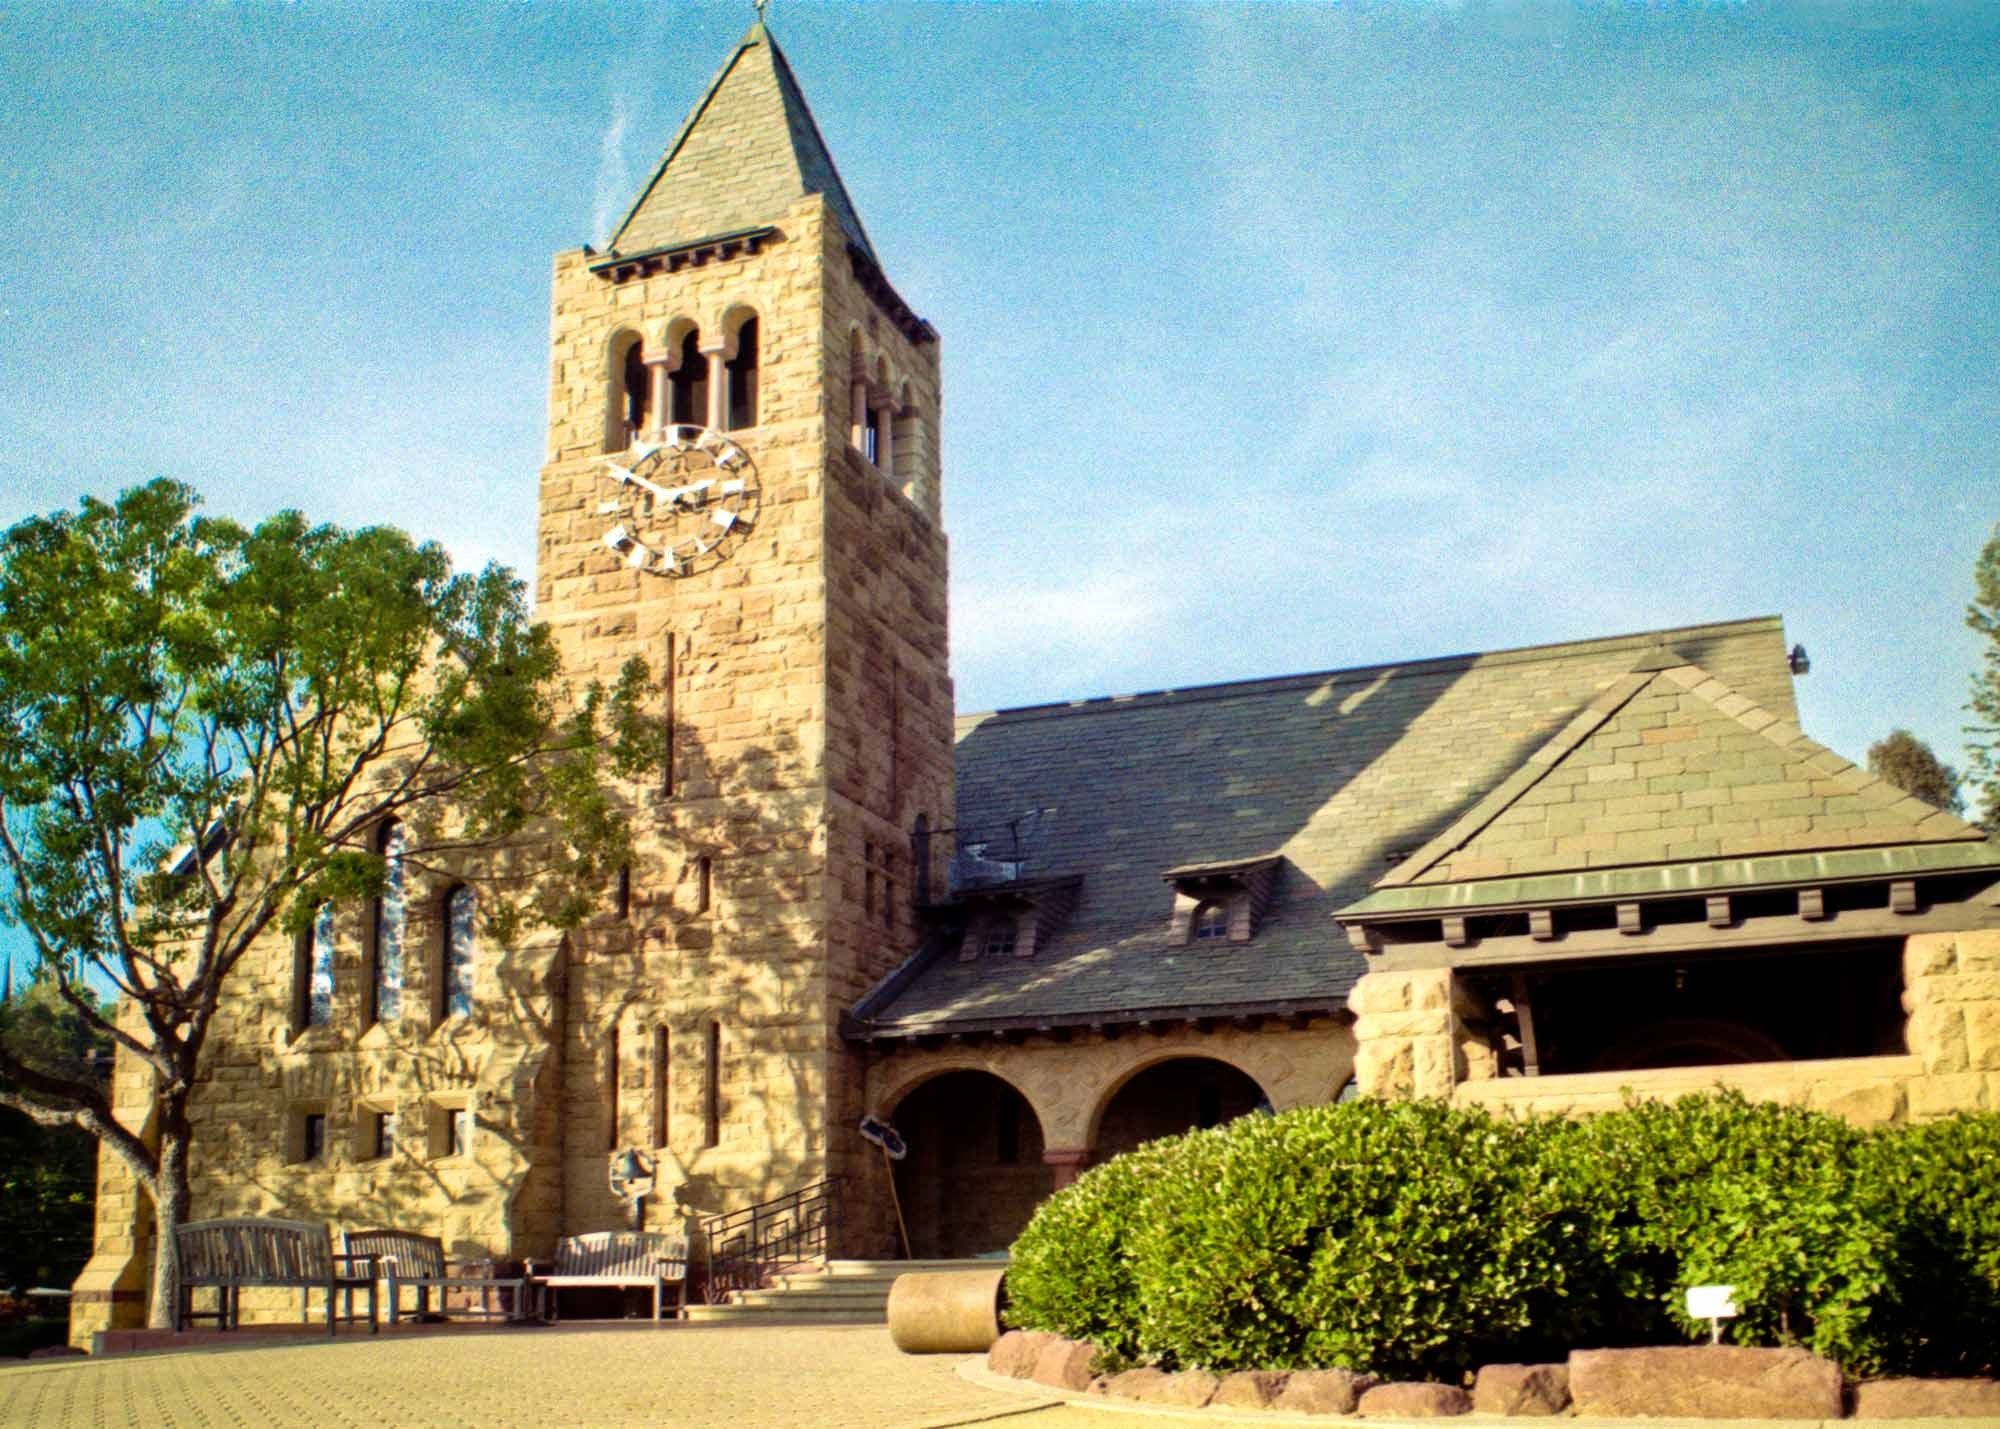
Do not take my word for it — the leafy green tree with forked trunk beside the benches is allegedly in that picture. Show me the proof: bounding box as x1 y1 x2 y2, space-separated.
0 480 658 1325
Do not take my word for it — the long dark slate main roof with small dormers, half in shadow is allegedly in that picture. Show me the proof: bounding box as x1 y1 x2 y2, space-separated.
858 616 1798 1035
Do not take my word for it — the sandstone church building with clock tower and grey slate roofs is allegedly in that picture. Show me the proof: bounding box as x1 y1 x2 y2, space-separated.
74 26 2000 1343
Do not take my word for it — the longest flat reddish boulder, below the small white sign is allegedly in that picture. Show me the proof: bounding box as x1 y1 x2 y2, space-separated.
1570 1345 1842 1419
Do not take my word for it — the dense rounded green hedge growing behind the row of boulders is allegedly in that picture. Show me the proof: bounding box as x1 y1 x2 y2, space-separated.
1008 1095 2000 1375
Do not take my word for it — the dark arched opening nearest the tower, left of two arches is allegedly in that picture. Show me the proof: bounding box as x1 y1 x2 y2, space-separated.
890 1069 1054 1259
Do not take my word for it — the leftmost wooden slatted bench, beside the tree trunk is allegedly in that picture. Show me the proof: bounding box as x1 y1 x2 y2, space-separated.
174 1219 378 1335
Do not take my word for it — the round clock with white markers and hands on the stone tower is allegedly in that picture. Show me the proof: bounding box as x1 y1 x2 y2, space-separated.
598 426 762 576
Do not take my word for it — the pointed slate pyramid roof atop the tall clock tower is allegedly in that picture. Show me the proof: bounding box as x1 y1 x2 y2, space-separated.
612 22 876 262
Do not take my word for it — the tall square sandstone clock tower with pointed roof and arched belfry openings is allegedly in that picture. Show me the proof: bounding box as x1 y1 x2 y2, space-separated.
536 24 952 1235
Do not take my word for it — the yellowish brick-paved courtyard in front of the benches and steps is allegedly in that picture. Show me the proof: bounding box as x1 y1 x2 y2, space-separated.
0 1325 1142 1429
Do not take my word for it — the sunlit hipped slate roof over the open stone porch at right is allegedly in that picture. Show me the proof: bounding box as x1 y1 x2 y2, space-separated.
1364 646 2000 888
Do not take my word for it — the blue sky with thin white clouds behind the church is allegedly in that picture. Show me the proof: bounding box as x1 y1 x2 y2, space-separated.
0 0 2000 992
